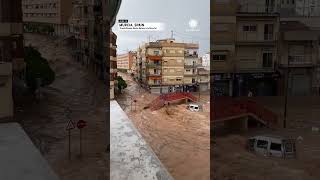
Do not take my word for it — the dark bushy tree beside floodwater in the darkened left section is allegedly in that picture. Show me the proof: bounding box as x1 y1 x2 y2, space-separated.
24 46 55 93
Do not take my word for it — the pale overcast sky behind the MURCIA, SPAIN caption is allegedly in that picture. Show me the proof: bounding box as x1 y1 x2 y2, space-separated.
112 0 210 56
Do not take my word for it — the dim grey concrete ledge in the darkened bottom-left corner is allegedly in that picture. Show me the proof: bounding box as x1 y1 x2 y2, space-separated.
0 123 59 180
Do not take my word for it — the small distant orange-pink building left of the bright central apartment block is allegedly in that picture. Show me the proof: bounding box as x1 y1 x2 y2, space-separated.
117 51 136 73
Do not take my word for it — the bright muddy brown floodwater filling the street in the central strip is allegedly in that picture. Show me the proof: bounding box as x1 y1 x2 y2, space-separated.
116 73 210 180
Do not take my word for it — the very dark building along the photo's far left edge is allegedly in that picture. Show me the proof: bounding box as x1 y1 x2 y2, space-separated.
0 0 25 121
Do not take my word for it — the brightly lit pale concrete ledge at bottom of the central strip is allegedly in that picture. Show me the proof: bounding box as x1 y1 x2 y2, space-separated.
110 101 173 180
